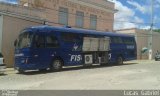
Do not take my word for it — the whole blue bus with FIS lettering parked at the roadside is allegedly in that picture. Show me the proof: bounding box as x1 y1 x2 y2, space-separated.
15 26 136 72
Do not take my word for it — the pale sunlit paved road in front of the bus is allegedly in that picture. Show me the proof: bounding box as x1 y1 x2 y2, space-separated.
0 61 160 90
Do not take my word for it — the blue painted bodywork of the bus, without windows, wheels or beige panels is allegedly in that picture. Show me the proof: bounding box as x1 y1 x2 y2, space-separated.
15 26 136 70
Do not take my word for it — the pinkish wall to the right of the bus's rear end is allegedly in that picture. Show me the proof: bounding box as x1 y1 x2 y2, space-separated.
136 29 160 59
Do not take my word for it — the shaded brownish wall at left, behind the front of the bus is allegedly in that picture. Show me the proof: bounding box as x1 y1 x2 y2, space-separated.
2 16 40 67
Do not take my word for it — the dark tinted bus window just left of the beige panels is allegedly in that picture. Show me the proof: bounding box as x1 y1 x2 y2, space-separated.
62 33 80 42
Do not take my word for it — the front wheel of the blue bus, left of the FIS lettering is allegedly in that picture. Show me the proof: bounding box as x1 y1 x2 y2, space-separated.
50 59 63 71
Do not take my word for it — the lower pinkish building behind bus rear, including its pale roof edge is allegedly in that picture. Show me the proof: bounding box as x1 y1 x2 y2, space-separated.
116 28 160 59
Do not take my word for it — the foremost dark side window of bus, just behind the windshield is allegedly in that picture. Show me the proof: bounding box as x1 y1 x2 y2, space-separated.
34 35 45 48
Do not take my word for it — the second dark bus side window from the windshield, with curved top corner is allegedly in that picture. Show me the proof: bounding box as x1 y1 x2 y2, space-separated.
46 35 59 48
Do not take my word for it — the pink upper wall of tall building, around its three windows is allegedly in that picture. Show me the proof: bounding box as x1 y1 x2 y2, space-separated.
20 0 115 31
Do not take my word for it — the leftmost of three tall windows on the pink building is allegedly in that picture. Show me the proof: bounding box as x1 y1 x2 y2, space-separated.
59 7 68 25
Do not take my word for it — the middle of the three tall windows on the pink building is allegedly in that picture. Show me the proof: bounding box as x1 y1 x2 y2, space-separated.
76 11 84 28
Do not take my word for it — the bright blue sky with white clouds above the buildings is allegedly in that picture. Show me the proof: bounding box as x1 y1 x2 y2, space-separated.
0 0 160 30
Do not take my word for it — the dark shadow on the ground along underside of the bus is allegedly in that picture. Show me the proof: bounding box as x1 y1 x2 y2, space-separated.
17 63 138 75
